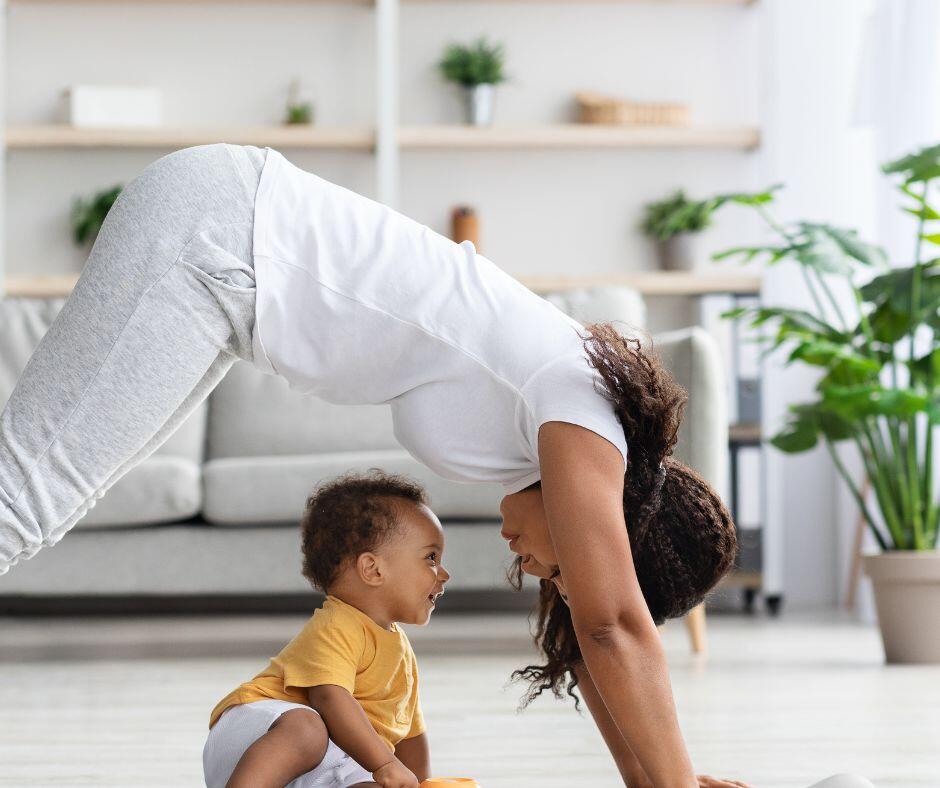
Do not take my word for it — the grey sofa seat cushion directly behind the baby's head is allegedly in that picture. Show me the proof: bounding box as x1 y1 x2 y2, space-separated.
203 449 502 525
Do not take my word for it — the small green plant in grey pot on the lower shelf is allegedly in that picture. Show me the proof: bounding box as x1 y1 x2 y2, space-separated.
640 190 726 271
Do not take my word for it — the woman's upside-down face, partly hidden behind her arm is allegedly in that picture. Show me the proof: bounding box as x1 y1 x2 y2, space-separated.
499 487 568 601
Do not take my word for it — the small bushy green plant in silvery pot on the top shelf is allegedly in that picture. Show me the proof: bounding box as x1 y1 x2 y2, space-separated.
438 38 506 126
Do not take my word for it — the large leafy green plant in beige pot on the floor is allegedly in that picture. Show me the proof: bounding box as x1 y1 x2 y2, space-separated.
715 145 940 663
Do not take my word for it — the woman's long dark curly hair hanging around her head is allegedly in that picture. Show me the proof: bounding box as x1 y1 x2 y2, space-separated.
509 323 737 708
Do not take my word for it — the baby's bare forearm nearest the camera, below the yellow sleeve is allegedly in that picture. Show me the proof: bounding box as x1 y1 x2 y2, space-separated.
307 684 414 775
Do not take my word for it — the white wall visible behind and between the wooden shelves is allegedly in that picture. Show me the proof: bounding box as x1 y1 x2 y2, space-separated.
6 2 759 275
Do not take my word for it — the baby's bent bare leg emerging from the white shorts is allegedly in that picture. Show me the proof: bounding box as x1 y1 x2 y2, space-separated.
226 709 329 788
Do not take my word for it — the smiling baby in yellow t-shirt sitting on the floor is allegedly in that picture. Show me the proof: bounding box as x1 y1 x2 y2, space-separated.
203 471 450 788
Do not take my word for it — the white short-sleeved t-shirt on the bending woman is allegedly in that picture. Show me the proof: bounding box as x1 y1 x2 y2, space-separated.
252 148 627 494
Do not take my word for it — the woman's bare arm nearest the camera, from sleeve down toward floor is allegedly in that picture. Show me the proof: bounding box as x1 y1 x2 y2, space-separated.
539 421 698 788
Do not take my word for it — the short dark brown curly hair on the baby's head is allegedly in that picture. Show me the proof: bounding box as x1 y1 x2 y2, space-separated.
300 468 428 593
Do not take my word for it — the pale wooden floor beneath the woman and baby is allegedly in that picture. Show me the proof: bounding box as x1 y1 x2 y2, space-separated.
0 612 940 788
